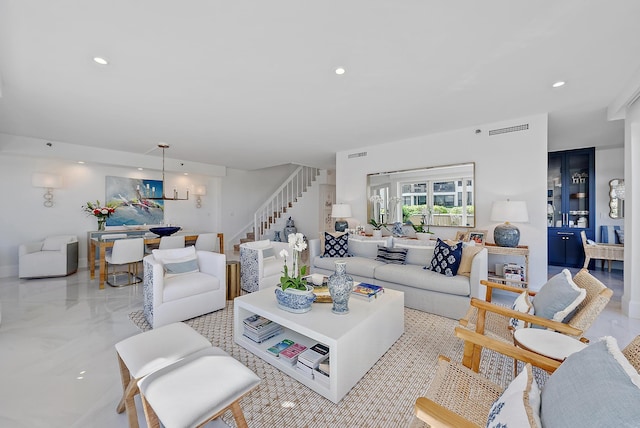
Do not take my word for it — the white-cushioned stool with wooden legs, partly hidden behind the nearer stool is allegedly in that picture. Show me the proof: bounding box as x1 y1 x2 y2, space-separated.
116 322 212 428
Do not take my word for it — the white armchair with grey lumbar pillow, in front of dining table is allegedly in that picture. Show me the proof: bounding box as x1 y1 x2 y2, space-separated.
143 246 227 328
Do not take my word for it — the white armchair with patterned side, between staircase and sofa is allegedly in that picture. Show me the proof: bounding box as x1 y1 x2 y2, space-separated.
240 239 293 293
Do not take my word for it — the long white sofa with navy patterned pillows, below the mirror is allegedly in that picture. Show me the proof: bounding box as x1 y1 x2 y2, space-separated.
309 237 487 319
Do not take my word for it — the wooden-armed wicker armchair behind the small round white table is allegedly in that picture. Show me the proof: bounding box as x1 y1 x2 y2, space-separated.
460 269 613 372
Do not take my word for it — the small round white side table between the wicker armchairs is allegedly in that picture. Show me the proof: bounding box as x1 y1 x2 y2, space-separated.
513 328 587 361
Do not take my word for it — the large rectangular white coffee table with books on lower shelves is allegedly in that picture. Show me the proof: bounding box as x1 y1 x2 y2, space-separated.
233 288 404 403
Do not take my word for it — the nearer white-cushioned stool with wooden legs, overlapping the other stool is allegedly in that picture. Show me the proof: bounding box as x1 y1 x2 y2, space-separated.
138 347 260 428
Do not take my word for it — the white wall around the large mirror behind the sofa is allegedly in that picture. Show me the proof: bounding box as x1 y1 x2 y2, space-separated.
336 114 547 289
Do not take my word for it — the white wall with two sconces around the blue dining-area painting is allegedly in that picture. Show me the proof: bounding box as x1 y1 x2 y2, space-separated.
0 153 224 277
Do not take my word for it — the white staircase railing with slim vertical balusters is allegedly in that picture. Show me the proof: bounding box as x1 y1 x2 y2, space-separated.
233 166 320 252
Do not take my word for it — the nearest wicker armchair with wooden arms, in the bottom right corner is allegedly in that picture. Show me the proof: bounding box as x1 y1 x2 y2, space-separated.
411 327 640 428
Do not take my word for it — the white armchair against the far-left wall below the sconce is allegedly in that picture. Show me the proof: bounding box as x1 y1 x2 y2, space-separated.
18 235 78 278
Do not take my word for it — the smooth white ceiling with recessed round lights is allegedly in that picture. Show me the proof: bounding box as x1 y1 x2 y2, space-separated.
0 0 640 169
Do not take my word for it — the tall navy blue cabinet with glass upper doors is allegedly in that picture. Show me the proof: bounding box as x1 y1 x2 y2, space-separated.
547 148 596 267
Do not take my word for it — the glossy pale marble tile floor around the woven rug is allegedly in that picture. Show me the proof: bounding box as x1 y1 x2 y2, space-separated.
0 267 640 428
